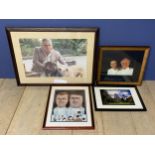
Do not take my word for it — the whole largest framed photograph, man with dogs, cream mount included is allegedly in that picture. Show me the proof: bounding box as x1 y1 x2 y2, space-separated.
6 28 98 85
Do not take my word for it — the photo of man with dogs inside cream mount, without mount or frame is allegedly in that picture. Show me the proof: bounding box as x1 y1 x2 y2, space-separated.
19 38 87 78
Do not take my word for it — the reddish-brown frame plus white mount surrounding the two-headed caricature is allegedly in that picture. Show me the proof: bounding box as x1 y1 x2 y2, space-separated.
43 86 95 130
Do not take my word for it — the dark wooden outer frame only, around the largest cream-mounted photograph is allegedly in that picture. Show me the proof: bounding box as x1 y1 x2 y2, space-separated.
5 27 99 86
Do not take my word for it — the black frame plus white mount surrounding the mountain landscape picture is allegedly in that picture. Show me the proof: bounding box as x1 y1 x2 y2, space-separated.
93 86 147 111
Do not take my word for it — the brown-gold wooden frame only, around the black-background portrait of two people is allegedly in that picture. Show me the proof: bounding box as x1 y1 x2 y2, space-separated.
96 46 150 85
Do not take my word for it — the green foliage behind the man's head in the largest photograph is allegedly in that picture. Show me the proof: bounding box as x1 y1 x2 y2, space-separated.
19 39 87 58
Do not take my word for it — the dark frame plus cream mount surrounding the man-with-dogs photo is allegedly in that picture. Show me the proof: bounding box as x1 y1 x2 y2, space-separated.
6 27 98 85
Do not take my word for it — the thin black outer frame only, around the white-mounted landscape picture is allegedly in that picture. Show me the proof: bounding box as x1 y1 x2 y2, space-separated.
93 85 147 112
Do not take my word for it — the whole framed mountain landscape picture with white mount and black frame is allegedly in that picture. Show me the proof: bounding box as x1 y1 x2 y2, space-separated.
94 86 146 111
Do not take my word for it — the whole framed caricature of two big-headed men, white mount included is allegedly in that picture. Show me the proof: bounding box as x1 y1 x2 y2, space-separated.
43 86 94 129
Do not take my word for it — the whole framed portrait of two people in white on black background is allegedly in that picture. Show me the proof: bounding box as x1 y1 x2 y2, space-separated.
97 46 150 85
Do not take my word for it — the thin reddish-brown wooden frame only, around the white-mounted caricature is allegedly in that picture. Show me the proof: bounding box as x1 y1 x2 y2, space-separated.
42 85 95 130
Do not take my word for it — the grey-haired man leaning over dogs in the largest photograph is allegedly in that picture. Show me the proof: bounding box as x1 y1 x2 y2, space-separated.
32 39 66 73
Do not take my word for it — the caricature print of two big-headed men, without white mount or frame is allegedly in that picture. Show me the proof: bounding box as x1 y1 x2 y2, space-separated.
51 90 87 122
